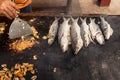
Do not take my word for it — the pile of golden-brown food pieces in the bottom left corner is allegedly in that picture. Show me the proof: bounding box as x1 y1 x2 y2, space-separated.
0 63 37 80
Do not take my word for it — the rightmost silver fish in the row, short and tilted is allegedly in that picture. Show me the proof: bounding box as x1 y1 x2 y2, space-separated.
100 17 113 40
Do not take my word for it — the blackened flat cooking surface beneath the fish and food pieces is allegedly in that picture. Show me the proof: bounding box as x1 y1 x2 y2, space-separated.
0 16 120 80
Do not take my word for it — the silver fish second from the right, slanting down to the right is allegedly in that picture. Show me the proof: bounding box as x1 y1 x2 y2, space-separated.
89 18 105 45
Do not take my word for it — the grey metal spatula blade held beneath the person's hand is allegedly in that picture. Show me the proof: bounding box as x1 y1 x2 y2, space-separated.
9 18 33 39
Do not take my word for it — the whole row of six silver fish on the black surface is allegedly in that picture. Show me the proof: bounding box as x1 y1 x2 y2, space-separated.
48 17 113 54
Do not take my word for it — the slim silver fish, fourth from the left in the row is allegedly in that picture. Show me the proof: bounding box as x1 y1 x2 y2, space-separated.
80 18 94 47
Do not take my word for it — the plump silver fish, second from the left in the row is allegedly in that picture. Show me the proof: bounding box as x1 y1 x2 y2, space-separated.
58 17 70 52
